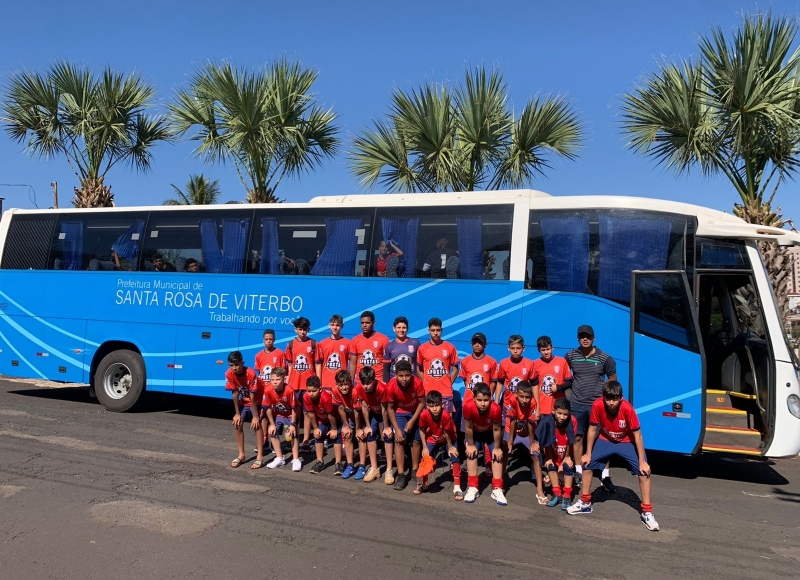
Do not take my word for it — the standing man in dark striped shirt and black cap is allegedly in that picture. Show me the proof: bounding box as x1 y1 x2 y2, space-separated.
564 324 617 492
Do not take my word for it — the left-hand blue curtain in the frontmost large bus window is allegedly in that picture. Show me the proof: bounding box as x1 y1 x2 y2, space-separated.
539 216 589 292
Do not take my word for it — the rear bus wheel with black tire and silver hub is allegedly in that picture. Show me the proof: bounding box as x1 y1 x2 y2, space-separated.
92 350 145 413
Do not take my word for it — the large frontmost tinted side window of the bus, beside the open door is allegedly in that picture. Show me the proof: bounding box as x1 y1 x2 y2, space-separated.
526 209 688 304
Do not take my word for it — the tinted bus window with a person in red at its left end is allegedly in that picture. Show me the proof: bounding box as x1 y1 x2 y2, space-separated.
369 205 513 280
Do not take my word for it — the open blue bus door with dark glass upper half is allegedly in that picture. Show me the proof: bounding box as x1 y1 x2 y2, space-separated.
629 270 705 453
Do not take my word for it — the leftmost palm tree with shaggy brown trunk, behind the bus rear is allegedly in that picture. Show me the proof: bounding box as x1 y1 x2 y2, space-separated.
2 61 169 207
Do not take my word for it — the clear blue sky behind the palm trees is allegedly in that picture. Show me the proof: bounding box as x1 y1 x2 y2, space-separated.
0 0 800 223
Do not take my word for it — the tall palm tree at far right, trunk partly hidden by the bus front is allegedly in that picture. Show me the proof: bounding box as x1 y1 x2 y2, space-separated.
622 13 800 312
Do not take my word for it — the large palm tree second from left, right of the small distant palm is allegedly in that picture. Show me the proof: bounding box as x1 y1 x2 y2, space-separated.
170 59 339 203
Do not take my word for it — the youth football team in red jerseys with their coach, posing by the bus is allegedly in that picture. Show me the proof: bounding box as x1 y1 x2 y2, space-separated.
225 311 659 531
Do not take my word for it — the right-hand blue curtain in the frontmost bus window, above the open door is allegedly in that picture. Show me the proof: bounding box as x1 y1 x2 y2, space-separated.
597 215 672 302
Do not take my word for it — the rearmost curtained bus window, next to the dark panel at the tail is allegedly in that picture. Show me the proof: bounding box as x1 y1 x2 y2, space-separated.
50 211 147 270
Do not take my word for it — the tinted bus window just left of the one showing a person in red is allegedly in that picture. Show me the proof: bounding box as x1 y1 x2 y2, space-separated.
247 207 375 276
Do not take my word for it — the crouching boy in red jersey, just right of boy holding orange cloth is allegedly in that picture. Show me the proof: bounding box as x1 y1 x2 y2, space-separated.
464 383 508 505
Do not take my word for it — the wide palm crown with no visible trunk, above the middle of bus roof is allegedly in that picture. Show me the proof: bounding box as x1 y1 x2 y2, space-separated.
350 67 583 191
